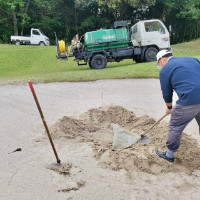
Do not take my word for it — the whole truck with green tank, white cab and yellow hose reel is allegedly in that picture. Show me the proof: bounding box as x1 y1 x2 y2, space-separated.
55 20 170 69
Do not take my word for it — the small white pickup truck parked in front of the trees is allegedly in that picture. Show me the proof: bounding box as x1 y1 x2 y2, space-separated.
10 28 50 46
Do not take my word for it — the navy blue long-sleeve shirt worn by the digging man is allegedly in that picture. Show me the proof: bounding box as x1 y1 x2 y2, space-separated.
160 57 200 105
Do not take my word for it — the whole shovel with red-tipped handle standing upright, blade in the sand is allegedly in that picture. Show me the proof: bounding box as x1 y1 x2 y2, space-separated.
28 81 68 173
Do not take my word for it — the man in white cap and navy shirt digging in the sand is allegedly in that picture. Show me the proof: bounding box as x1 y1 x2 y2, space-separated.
155 50 200 162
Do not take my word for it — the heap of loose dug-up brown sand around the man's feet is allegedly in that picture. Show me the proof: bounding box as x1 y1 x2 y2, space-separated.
50 106 200 174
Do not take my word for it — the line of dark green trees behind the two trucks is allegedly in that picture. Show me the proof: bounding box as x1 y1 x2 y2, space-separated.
0 0 200 44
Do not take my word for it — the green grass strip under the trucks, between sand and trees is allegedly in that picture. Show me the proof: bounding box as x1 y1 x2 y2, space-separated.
0 40 200 85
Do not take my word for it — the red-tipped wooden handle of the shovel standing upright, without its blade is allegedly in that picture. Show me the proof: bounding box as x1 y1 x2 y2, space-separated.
28 81 61 163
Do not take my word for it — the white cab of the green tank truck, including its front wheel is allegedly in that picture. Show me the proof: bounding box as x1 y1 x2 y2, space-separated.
131 19 170 62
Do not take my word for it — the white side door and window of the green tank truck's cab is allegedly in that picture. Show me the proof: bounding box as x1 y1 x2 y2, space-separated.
142 20 170 49
